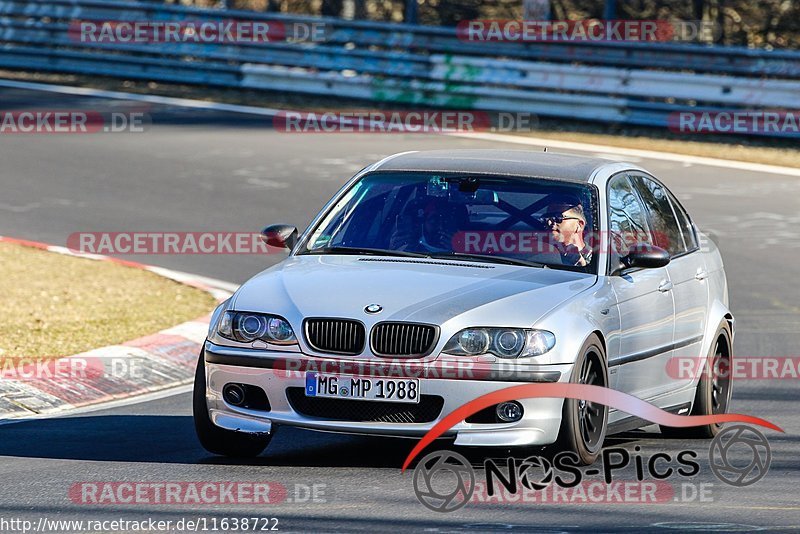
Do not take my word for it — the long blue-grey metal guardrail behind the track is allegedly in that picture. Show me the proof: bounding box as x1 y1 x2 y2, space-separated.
0 0 800 136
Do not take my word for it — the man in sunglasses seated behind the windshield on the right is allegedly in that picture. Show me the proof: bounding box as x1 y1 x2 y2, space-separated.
542 195 592 267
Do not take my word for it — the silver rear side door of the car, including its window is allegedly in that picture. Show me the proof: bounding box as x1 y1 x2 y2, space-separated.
632 174 708 390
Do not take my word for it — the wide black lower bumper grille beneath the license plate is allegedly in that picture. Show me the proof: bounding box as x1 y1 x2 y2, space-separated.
286 388 444 423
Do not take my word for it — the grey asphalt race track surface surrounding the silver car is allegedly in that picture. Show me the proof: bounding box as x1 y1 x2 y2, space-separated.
0 89 800 532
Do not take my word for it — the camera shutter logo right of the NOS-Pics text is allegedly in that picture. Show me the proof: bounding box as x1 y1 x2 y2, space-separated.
708 425 772 487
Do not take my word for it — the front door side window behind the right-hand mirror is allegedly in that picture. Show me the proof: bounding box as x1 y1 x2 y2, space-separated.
608 174 655 265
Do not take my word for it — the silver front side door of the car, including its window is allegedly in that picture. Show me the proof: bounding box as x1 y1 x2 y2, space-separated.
607 173 675 399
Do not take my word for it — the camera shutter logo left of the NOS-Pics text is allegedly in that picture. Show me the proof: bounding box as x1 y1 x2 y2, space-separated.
413 451 475 512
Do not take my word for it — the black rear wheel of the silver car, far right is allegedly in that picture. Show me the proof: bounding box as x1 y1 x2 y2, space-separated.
661 323 733 439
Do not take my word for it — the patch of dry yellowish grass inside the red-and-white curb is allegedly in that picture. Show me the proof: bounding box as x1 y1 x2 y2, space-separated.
0 242 216 360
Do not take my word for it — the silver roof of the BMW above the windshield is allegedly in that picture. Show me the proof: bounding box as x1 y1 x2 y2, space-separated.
373 150 610 182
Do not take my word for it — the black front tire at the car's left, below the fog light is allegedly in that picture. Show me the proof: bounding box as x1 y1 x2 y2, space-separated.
192 353 272 458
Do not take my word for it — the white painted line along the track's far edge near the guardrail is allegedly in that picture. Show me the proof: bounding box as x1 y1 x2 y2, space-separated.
0 80 800 176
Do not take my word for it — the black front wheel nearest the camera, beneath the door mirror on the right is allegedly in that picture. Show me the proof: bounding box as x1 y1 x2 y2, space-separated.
554 334 608 465
